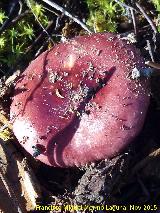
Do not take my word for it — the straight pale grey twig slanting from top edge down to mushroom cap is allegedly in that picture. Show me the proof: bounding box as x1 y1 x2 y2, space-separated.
42 0 92 34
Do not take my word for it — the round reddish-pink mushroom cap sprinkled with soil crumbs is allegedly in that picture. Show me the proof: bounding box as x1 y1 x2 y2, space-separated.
10 33 150 167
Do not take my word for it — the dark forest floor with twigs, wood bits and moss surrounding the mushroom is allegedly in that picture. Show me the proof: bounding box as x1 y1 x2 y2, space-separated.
0 0 160 213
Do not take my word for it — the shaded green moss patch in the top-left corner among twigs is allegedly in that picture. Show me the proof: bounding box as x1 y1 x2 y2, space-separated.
0 1 49 70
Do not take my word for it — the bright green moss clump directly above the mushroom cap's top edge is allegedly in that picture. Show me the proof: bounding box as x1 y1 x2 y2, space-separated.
86 0 124 32
